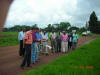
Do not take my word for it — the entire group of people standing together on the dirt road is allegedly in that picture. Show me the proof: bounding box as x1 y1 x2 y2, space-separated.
18 28 78 69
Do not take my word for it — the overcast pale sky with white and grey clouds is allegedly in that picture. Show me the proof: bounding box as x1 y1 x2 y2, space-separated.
5 0 100 27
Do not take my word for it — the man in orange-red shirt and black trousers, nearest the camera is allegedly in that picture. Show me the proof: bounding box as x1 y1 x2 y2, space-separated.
21 28 33 69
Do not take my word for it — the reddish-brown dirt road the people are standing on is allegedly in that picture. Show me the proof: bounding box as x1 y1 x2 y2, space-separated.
0 35 98 75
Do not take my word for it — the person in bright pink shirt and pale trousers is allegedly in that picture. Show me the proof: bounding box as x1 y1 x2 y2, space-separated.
61 32 68 53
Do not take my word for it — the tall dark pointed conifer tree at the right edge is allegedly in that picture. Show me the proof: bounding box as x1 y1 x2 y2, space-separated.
89 11 98 33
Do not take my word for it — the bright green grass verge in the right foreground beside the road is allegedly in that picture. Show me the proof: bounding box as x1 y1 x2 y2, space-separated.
22 38 100 75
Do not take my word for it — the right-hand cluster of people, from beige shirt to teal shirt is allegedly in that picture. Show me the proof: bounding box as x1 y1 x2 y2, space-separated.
49 32 78 53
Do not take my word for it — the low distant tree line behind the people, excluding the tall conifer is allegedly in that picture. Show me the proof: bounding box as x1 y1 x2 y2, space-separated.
3 22 86 32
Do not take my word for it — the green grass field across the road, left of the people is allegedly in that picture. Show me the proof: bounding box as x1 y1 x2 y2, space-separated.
0 32 19 47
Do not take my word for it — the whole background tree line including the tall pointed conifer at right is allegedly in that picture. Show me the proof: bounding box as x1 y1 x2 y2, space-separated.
3 11 100 33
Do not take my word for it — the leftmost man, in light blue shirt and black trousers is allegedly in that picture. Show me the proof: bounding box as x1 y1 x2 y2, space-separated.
18 28 25 56
